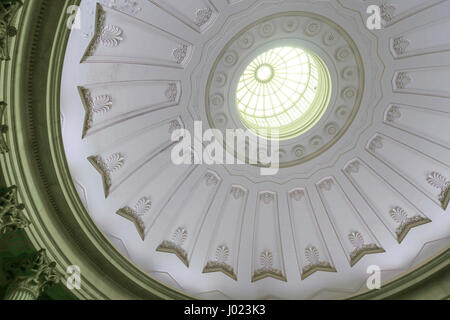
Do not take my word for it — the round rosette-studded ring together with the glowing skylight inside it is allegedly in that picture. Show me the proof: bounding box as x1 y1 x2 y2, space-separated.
205 11 364 168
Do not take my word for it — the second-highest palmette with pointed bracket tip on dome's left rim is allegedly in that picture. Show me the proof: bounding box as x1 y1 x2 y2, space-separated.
78 87 113 138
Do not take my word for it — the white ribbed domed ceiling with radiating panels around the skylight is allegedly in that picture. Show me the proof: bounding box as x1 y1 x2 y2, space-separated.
61 0 450 299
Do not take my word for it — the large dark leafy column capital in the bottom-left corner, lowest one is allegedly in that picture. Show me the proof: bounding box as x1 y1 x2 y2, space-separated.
7 249 60 299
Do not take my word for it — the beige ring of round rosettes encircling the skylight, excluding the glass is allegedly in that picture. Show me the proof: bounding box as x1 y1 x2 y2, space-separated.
205 12 364 168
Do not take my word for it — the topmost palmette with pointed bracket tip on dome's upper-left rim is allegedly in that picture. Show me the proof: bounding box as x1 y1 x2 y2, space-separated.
84 4 123 57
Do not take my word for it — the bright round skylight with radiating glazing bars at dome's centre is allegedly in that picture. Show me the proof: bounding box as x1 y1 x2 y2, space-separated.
236 47 331 139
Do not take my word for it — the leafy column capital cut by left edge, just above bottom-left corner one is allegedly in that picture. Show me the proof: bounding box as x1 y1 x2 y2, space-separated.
0 186 30 234
